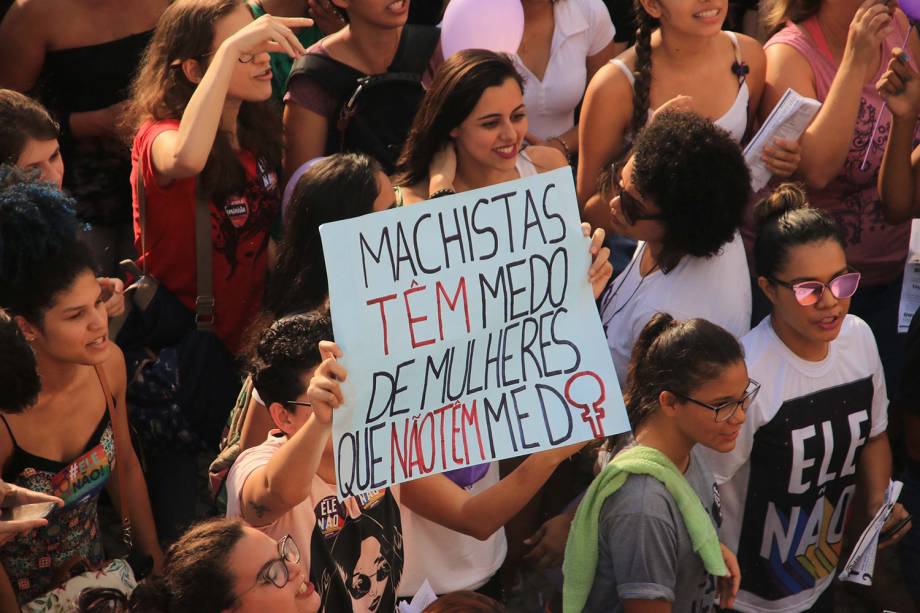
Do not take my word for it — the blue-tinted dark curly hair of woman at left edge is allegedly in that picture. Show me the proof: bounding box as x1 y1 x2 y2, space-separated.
0 167 94 326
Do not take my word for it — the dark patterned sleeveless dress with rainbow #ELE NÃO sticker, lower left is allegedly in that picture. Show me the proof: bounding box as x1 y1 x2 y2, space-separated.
0 402 115 604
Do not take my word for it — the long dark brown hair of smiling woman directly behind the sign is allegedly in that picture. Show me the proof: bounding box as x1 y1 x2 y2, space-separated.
396 49 524 185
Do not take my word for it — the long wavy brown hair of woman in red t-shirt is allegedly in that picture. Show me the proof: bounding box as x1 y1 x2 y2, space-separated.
126 0 281 202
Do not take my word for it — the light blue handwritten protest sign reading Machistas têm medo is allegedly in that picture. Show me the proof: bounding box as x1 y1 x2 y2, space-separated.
320 167 629 498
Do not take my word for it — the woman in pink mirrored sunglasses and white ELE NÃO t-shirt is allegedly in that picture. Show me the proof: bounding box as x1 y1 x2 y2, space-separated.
708 184 910 611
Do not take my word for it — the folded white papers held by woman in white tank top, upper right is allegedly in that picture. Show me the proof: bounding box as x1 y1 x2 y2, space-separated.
744 89 821 192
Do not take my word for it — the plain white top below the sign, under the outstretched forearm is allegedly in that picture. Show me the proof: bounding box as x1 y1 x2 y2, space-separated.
399 462 508 597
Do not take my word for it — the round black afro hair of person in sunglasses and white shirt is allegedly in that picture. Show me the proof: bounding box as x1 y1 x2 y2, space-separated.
631 112 751 272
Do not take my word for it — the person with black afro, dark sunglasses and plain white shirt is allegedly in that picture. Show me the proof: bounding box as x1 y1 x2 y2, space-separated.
601 107 751 381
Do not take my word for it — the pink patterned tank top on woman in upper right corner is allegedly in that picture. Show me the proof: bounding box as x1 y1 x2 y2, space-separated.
764 17 920 285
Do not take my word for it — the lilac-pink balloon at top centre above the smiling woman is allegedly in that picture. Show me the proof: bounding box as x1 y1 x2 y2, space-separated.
441 0 528 57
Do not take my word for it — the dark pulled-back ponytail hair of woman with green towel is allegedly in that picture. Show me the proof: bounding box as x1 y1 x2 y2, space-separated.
623 313 744 430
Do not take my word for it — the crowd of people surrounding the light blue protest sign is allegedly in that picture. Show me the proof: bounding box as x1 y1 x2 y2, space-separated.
0 0 920 613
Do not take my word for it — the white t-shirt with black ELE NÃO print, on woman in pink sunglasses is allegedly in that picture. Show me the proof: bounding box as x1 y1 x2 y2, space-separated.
704 315 888 612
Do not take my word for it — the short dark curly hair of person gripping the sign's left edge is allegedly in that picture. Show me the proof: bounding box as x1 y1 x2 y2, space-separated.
249 310 333 408
